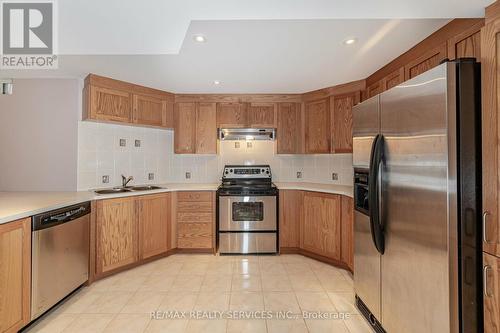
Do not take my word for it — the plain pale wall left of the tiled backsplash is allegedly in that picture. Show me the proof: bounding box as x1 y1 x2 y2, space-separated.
0 79 81 191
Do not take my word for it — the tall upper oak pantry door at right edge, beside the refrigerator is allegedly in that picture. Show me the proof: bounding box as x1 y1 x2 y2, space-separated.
481 18 500 256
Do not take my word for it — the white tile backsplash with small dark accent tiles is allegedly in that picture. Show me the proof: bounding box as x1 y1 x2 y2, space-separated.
78 121 353 190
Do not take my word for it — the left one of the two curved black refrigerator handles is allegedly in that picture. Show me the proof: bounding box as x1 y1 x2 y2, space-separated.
368 134 385 254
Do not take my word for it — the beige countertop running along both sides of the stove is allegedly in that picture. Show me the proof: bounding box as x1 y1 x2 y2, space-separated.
0 182 353 224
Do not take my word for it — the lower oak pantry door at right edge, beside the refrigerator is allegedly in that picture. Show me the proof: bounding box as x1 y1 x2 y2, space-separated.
483 253 500 333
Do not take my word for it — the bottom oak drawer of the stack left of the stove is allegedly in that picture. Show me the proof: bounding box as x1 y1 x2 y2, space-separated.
177 223 212 249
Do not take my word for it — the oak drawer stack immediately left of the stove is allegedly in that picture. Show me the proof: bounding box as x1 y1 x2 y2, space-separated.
175 191 215 250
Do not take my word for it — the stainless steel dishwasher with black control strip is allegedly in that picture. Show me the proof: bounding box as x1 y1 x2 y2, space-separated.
31 202 90 320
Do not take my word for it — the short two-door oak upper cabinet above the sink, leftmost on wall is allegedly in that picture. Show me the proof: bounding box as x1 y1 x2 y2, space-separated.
83 74 174 128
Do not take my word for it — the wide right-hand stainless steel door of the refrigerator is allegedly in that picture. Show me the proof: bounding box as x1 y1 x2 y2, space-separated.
380 64 458 333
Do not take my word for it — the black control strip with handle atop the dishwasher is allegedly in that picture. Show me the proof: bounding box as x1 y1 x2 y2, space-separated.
32 202 90 231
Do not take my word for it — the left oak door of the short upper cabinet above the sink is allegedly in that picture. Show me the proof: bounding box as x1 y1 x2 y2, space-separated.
89 86 132 123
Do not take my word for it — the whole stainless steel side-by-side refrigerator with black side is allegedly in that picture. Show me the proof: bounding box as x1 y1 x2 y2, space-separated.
353 59 482 333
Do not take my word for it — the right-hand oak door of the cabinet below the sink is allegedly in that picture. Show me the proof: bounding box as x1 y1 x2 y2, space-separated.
137 193 171 259
